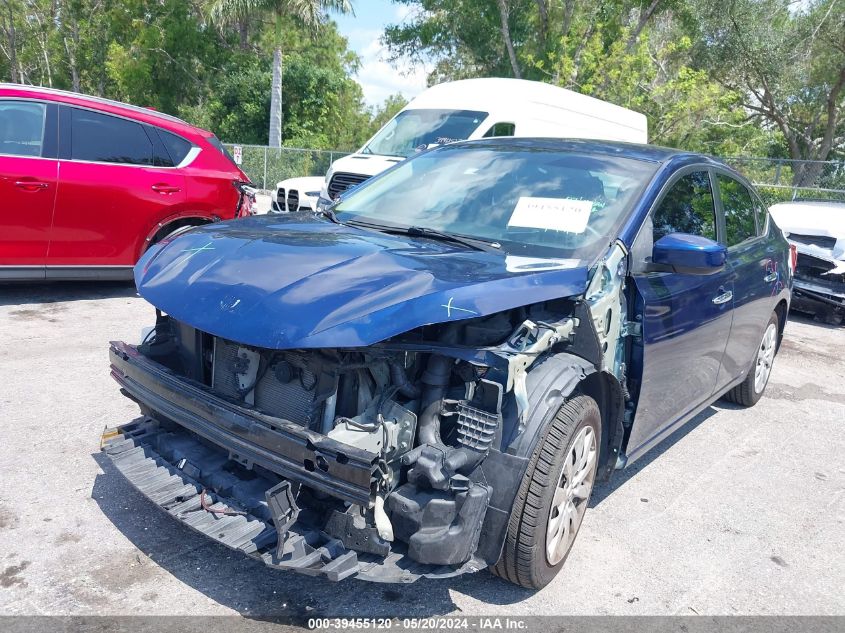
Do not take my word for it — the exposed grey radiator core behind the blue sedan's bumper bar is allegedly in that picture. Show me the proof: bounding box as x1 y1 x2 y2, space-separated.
211 338 319 426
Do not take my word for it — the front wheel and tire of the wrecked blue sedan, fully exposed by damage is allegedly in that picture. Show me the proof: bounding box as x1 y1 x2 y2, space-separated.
491 396 601 589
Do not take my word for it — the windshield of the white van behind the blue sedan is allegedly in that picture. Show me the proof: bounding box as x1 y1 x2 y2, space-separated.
362 110 487 157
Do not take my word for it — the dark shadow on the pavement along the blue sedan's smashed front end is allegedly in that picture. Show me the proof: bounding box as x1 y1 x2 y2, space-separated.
87 453 534 620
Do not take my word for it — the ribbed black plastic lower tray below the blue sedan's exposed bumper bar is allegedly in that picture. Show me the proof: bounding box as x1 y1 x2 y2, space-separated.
102 418 486 583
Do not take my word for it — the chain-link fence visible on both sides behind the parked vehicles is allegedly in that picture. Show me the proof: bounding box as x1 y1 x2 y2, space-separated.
224 143 845 204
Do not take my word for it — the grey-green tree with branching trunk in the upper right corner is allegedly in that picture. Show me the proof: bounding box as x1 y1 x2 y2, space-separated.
692 0 845 186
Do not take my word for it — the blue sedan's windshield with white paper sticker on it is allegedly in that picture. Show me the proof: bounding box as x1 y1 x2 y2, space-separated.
333 141 657 261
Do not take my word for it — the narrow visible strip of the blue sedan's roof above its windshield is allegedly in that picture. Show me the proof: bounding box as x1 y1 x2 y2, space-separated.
449 136 720 165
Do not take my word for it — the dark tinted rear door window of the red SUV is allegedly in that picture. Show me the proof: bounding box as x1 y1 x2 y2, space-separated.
71 108 154 165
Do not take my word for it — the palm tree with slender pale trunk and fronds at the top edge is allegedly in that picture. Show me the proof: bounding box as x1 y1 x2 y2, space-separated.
210 0 352 147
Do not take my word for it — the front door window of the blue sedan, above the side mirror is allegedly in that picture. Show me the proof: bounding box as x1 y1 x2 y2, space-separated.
652 170 716 242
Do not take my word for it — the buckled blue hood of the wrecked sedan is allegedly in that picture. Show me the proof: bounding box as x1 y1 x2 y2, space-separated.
135 213 588 349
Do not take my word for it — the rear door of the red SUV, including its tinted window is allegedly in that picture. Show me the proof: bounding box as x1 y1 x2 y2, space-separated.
47 106 186 277
